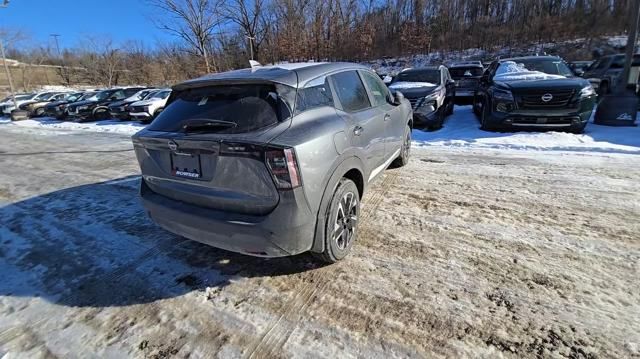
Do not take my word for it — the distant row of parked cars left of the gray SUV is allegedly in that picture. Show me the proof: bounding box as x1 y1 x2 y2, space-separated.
0 87 171 122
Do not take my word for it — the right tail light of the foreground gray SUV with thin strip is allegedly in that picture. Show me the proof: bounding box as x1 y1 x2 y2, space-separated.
220 142 302 190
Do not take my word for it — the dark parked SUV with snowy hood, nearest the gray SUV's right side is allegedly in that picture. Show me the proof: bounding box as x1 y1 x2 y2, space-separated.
389 66 456 129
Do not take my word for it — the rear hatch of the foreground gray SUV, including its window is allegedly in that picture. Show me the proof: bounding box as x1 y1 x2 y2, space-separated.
133 84 295 215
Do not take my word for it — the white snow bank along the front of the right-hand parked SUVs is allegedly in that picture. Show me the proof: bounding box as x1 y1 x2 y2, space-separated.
413 106 640 154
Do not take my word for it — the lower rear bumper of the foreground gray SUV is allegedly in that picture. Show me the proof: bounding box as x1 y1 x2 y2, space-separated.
140 180 315 257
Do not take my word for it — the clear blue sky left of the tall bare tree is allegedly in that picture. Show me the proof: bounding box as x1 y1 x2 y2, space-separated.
0 0 174 48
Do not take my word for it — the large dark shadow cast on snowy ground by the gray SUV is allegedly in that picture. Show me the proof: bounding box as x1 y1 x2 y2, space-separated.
0 176 320 307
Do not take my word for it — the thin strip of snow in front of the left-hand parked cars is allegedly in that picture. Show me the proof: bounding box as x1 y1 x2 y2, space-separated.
9 117 145 135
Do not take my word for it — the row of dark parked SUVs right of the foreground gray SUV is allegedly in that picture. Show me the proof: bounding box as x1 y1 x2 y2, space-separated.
381 55 640 133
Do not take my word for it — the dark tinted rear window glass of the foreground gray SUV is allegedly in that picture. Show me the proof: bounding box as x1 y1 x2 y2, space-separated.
148 84 290 133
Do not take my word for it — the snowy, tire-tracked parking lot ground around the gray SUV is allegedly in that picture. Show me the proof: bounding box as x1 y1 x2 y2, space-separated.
0 106 640 358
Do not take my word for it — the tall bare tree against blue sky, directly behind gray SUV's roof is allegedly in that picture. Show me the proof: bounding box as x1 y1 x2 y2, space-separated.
149 0 225 72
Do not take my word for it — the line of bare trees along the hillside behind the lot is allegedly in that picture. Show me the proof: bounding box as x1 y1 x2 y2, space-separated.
0 0 634 86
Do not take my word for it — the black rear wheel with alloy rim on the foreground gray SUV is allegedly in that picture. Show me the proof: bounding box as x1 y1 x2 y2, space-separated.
313 178 360 263
